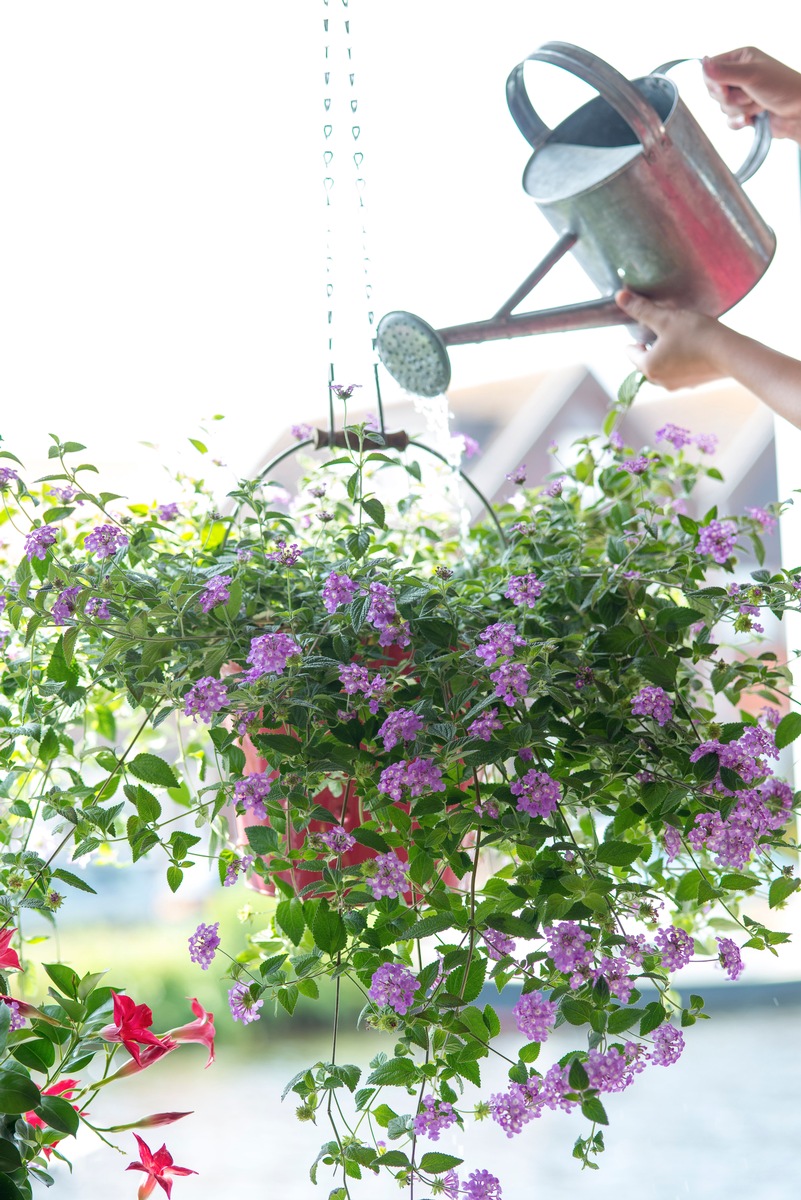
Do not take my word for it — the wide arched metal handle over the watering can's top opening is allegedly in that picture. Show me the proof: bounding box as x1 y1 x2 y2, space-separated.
506 42 666 157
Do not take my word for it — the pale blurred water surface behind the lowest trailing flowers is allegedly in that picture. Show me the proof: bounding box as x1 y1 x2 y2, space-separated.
48 1007 801 1200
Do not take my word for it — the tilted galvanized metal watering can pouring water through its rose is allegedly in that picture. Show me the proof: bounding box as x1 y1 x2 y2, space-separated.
375 42 776 396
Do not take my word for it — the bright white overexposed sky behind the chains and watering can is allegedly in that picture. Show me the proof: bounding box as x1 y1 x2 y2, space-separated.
0 0 801 499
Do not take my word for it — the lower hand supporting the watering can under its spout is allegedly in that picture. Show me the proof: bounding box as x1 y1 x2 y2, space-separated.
615 289 730 391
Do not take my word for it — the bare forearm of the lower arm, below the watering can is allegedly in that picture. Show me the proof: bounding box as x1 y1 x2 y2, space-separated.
711 325 801 428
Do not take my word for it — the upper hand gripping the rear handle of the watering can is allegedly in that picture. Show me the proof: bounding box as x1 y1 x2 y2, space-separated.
703 46 801 144
